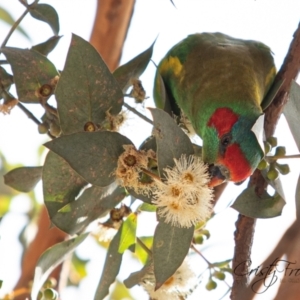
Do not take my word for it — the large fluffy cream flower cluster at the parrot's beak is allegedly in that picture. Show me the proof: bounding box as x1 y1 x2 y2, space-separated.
153 155 212 227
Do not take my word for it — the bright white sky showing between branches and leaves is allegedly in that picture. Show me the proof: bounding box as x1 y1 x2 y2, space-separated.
0 0 300 300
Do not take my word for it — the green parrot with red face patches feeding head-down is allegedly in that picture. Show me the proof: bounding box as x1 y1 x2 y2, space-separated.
154 33 276 186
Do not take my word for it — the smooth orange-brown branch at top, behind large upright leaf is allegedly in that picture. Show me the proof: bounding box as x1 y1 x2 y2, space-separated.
90 0 135 71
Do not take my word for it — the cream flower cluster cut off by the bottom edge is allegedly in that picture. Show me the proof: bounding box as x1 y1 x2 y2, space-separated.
141 261 196 300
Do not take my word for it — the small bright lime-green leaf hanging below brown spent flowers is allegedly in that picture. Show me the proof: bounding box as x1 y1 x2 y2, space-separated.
119 213 137 253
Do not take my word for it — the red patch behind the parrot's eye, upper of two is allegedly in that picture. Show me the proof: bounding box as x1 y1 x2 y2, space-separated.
207 107 239 137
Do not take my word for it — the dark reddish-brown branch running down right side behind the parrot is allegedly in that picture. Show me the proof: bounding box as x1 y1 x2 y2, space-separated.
231 23 300 300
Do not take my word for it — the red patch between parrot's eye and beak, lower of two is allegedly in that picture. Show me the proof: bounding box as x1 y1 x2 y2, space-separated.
218 143 252 182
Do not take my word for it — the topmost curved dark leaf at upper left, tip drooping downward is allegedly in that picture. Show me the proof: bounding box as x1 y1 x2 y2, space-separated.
29 4 59 35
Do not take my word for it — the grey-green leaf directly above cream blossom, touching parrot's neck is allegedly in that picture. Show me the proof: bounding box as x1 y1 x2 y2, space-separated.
150 108 194 174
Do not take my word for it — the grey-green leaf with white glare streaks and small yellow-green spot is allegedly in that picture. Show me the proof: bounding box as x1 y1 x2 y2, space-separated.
51 183 126 235
